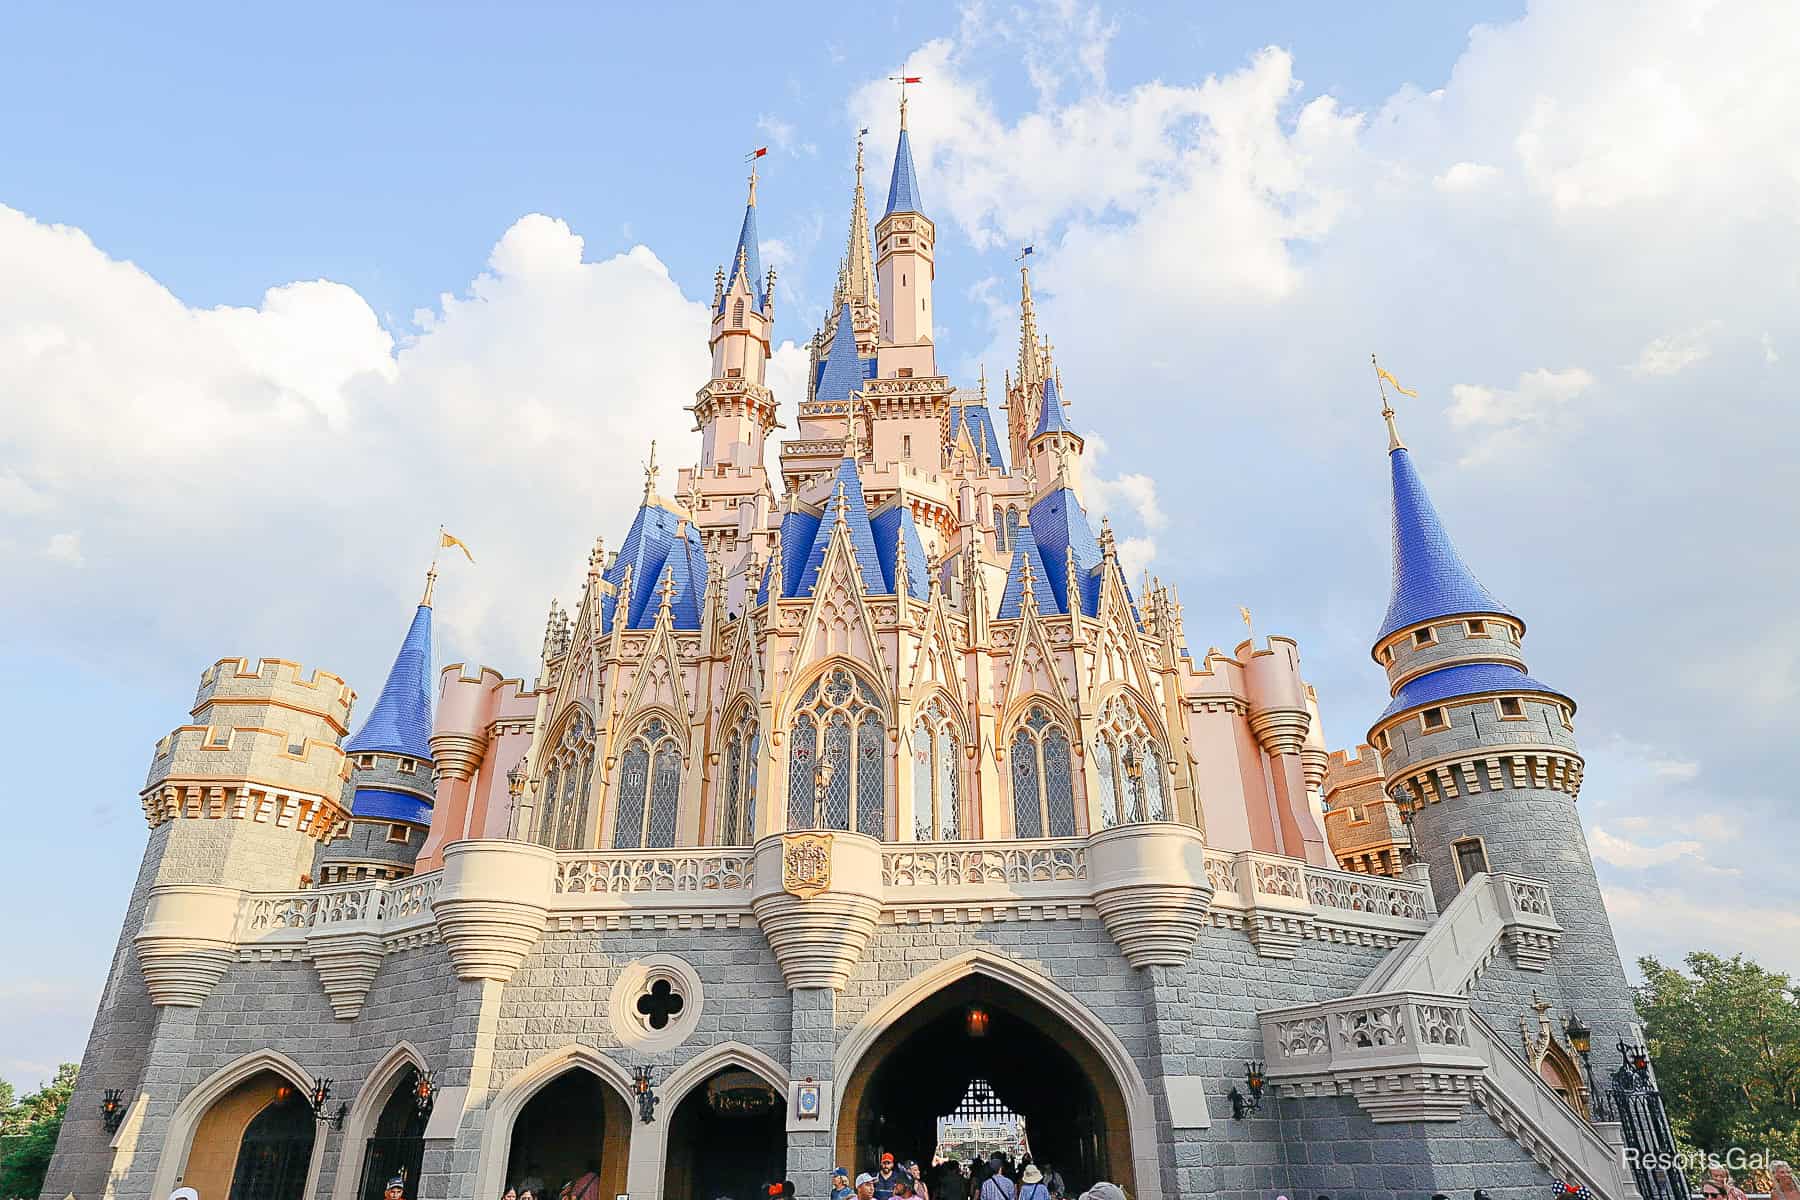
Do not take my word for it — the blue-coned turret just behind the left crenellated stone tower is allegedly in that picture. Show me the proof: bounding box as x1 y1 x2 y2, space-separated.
313 567 437 883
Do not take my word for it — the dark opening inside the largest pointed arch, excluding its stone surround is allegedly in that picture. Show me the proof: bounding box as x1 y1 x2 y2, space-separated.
837 964 1141 1196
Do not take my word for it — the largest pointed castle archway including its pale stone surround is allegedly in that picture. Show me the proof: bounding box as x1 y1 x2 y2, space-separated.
835 955 1161 1196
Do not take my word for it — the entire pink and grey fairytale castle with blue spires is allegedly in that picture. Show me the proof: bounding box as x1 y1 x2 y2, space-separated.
43 103 1645 1200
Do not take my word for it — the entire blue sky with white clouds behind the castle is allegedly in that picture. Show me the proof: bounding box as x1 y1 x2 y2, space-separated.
0 0 1800 1083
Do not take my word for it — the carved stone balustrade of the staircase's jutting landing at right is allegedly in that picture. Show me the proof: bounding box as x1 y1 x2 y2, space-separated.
1262 991 1487 1123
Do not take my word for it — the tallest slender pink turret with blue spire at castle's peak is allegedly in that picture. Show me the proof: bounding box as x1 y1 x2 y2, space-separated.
875 94 938 378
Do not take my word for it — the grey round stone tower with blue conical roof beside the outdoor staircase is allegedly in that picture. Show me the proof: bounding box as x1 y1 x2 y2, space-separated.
1368 395 1633 1043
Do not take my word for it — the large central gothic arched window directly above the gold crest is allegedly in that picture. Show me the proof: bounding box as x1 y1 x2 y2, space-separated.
788 667 887 838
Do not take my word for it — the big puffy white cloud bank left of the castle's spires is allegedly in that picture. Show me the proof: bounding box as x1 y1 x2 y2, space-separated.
0 209 712 676
